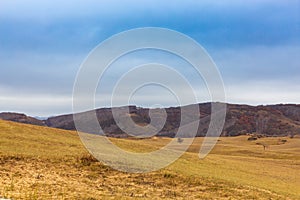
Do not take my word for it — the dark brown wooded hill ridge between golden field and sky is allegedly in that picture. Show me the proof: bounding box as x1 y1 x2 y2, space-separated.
0 103 300 137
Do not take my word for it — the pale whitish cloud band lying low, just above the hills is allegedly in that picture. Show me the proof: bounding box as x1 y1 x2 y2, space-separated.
0 76 300 117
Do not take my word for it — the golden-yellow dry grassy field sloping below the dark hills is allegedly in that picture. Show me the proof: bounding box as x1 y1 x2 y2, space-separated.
0 120 300 200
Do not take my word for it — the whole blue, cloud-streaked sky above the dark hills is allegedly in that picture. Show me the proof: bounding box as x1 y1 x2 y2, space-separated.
0 0 300 116
